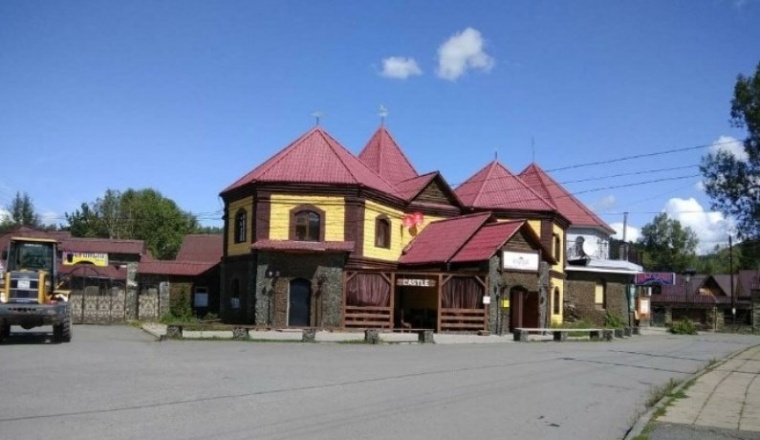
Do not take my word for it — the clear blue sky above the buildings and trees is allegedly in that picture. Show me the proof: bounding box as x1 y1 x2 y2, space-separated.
0 0 760 253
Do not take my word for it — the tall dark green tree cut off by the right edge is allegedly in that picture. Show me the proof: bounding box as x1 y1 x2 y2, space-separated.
700 63 760 261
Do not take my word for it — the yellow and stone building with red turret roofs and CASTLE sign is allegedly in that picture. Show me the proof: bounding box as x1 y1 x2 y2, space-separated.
220 126 568 332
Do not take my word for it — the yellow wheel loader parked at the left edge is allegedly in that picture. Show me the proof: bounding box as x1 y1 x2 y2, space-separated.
0 237 71 342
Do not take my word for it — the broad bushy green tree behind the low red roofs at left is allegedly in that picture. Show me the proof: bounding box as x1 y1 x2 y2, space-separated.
66 189 198 259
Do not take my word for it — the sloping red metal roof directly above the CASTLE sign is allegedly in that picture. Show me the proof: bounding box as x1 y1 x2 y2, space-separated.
399 212 491 264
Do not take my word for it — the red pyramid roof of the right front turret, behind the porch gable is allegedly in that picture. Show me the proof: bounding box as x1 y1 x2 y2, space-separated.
454 161 556 211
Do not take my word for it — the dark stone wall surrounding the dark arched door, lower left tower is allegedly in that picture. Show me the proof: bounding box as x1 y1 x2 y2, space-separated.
256 252 345 328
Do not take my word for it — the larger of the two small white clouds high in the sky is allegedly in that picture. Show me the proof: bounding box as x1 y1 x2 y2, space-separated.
437 28 494 81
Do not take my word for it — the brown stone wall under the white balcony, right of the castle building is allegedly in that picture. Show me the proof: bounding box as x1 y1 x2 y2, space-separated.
564 272 628 326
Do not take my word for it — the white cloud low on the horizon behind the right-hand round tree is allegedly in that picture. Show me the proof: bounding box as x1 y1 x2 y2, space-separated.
663 198 731 255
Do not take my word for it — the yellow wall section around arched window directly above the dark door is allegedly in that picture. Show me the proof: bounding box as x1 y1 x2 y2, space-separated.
269 194 346 241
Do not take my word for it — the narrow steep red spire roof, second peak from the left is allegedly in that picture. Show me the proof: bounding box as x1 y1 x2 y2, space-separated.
359 125 418 185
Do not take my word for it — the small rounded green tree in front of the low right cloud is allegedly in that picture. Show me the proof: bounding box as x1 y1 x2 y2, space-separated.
637 213 699 273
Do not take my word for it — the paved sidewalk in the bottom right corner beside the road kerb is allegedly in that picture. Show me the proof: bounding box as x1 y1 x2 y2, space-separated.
649 346 760 440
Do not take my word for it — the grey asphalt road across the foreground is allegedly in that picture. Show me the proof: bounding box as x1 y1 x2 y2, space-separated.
0 326 759 440
